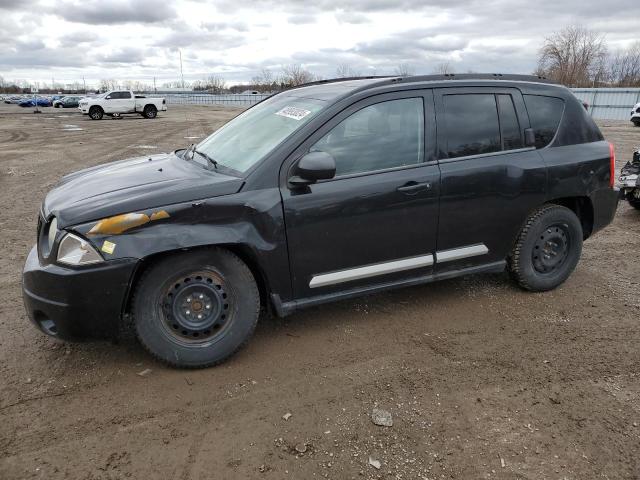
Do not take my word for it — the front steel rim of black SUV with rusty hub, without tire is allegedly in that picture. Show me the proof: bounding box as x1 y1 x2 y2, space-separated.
160 271 234 346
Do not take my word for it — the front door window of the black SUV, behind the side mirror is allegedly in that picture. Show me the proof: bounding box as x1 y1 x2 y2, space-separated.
310 98 424 176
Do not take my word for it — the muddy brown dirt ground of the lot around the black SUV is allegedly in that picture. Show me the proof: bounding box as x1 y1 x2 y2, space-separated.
0 105 640 480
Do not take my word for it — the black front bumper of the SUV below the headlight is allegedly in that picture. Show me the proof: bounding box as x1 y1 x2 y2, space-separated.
22 246 136 340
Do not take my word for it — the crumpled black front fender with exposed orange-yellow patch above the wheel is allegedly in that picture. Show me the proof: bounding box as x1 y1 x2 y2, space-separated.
73 189 291 299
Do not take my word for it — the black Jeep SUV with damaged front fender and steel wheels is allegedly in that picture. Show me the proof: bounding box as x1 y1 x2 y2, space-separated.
23 75 617 367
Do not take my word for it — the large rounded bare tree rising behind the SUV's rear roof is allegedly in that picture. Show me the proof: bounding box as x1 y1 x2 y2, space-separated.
538 26 607 87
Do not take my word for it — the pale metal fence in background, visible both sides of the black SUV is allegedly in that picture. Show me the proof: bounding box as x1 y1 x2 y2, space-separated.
164 88 640 120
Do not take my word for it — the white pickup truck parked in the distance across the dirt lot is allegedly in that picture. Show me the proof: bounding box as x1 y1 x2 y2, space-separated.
78 90 167 120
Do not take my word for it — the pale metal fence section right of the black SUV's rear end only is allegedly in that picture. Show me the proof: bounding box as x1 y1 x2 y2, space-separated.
572 88 640 120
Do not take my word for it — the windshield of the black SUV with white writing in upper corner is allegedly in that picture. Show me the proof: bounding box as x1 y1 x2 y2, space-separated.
196 95 326 173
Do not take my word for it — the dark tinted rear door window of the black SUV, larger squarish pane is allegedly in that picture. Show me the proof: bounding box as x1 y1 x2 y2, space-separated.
444 93 500 158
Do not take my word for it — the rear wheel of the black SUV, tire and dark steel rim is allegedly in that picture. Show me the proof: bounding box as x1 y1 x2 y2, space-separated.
507 205 583 292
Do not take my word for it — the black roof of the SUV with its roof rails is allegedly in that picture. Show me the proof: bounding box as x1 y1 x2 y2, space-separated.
282 73 558 101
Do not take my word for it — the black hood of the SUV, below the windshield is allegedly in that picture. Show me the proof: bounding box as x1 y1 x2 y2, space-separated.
42 153 243 228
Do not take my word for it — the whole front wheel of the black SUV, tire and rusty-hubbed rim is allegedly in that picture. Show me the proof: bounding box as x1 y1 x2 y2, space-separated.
132 248 260 368
